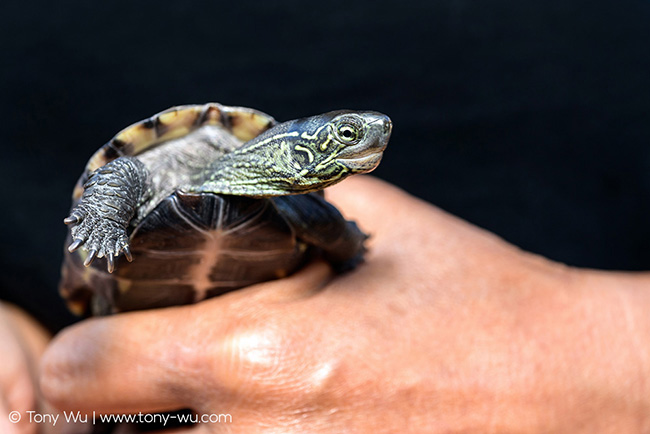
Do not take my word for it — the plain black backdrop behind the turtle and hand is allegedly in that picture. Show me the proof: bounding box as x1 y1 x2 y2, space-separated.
0 0 650 327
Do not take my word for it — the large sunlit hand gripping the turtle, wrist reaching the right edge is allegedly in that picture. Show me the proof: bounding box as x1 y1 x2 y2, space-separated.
41 177 650 433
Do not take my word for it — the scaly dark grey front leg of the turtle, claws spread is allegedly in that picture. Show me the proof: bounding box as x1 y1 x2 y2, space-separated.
63 157 148 273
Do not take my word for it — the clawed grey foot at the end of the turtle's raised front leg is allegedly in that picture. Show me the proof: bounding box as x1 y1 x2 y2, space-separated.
63 207 133 273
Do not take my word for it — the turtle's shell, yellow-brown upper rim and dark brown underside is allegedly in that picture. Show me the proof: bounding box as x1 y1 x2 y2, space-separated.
60 103 310 315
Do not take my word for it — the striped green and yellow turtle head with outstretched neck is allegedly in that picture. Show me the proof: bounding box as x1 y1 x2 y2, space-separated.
195 110 392 197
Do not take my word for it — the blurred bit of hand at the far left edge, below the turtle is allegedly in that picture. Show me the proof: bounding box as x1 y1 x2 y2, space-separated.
0 302 49 434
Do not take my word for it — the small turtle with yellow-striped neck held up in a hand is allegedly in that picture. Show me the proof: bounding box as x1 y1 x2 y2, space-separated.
59 103 392 316
